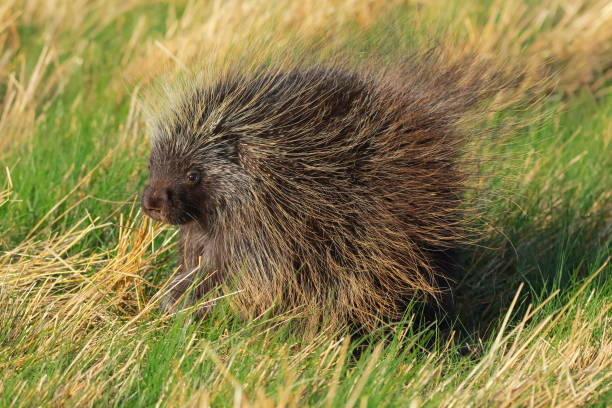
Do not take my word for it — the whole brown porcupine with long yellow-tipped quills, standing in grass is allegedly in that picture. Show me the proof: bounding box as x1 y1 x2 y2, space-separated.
142 53 504 327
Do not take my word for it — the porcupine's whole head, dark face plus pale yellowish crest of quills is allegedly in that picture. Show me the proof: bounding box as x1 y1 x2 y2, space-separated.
141 81 248 230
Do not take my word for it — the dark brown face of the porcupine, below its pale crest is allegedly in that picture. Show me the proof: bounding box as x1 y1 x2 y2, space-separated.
141 126 248 230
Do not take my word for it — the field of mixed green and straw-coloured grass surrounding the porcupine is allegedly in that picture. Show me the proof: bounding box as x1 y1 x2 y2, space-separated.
0 0 612 407
